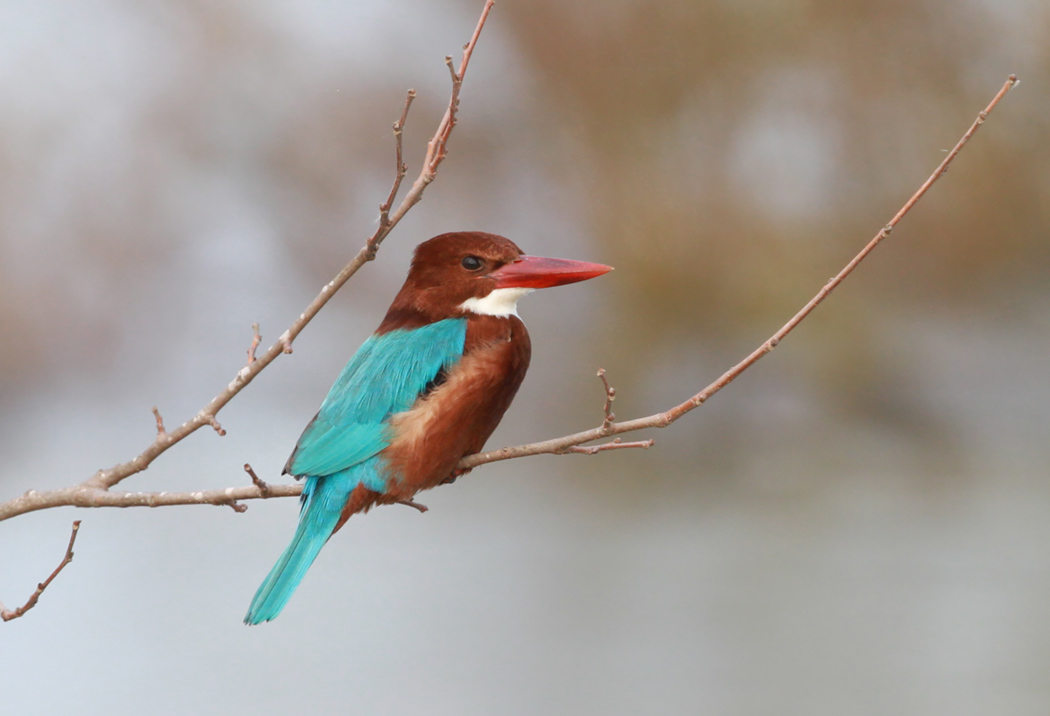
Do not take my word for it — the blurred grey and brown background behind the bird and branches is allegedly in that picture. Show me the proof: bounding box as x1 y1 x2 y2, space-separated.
0 0 1050 715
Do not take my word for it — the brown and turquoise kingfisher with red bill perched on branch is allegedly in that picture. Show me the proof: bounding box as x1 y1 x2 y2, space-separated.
245 231 612 625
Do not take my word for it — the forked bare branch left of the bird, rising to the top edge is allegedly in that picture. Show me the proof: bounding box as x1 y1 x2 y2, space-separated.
0 0 495 522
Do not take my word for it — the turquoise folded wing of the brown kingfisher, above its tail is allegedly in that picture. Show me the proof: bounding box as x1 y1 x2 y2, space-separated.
286 318 466 477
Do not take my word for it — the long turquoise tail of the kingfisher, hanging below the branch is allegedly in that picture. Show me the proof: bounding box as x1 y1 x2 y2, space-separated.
245 468 359 625
